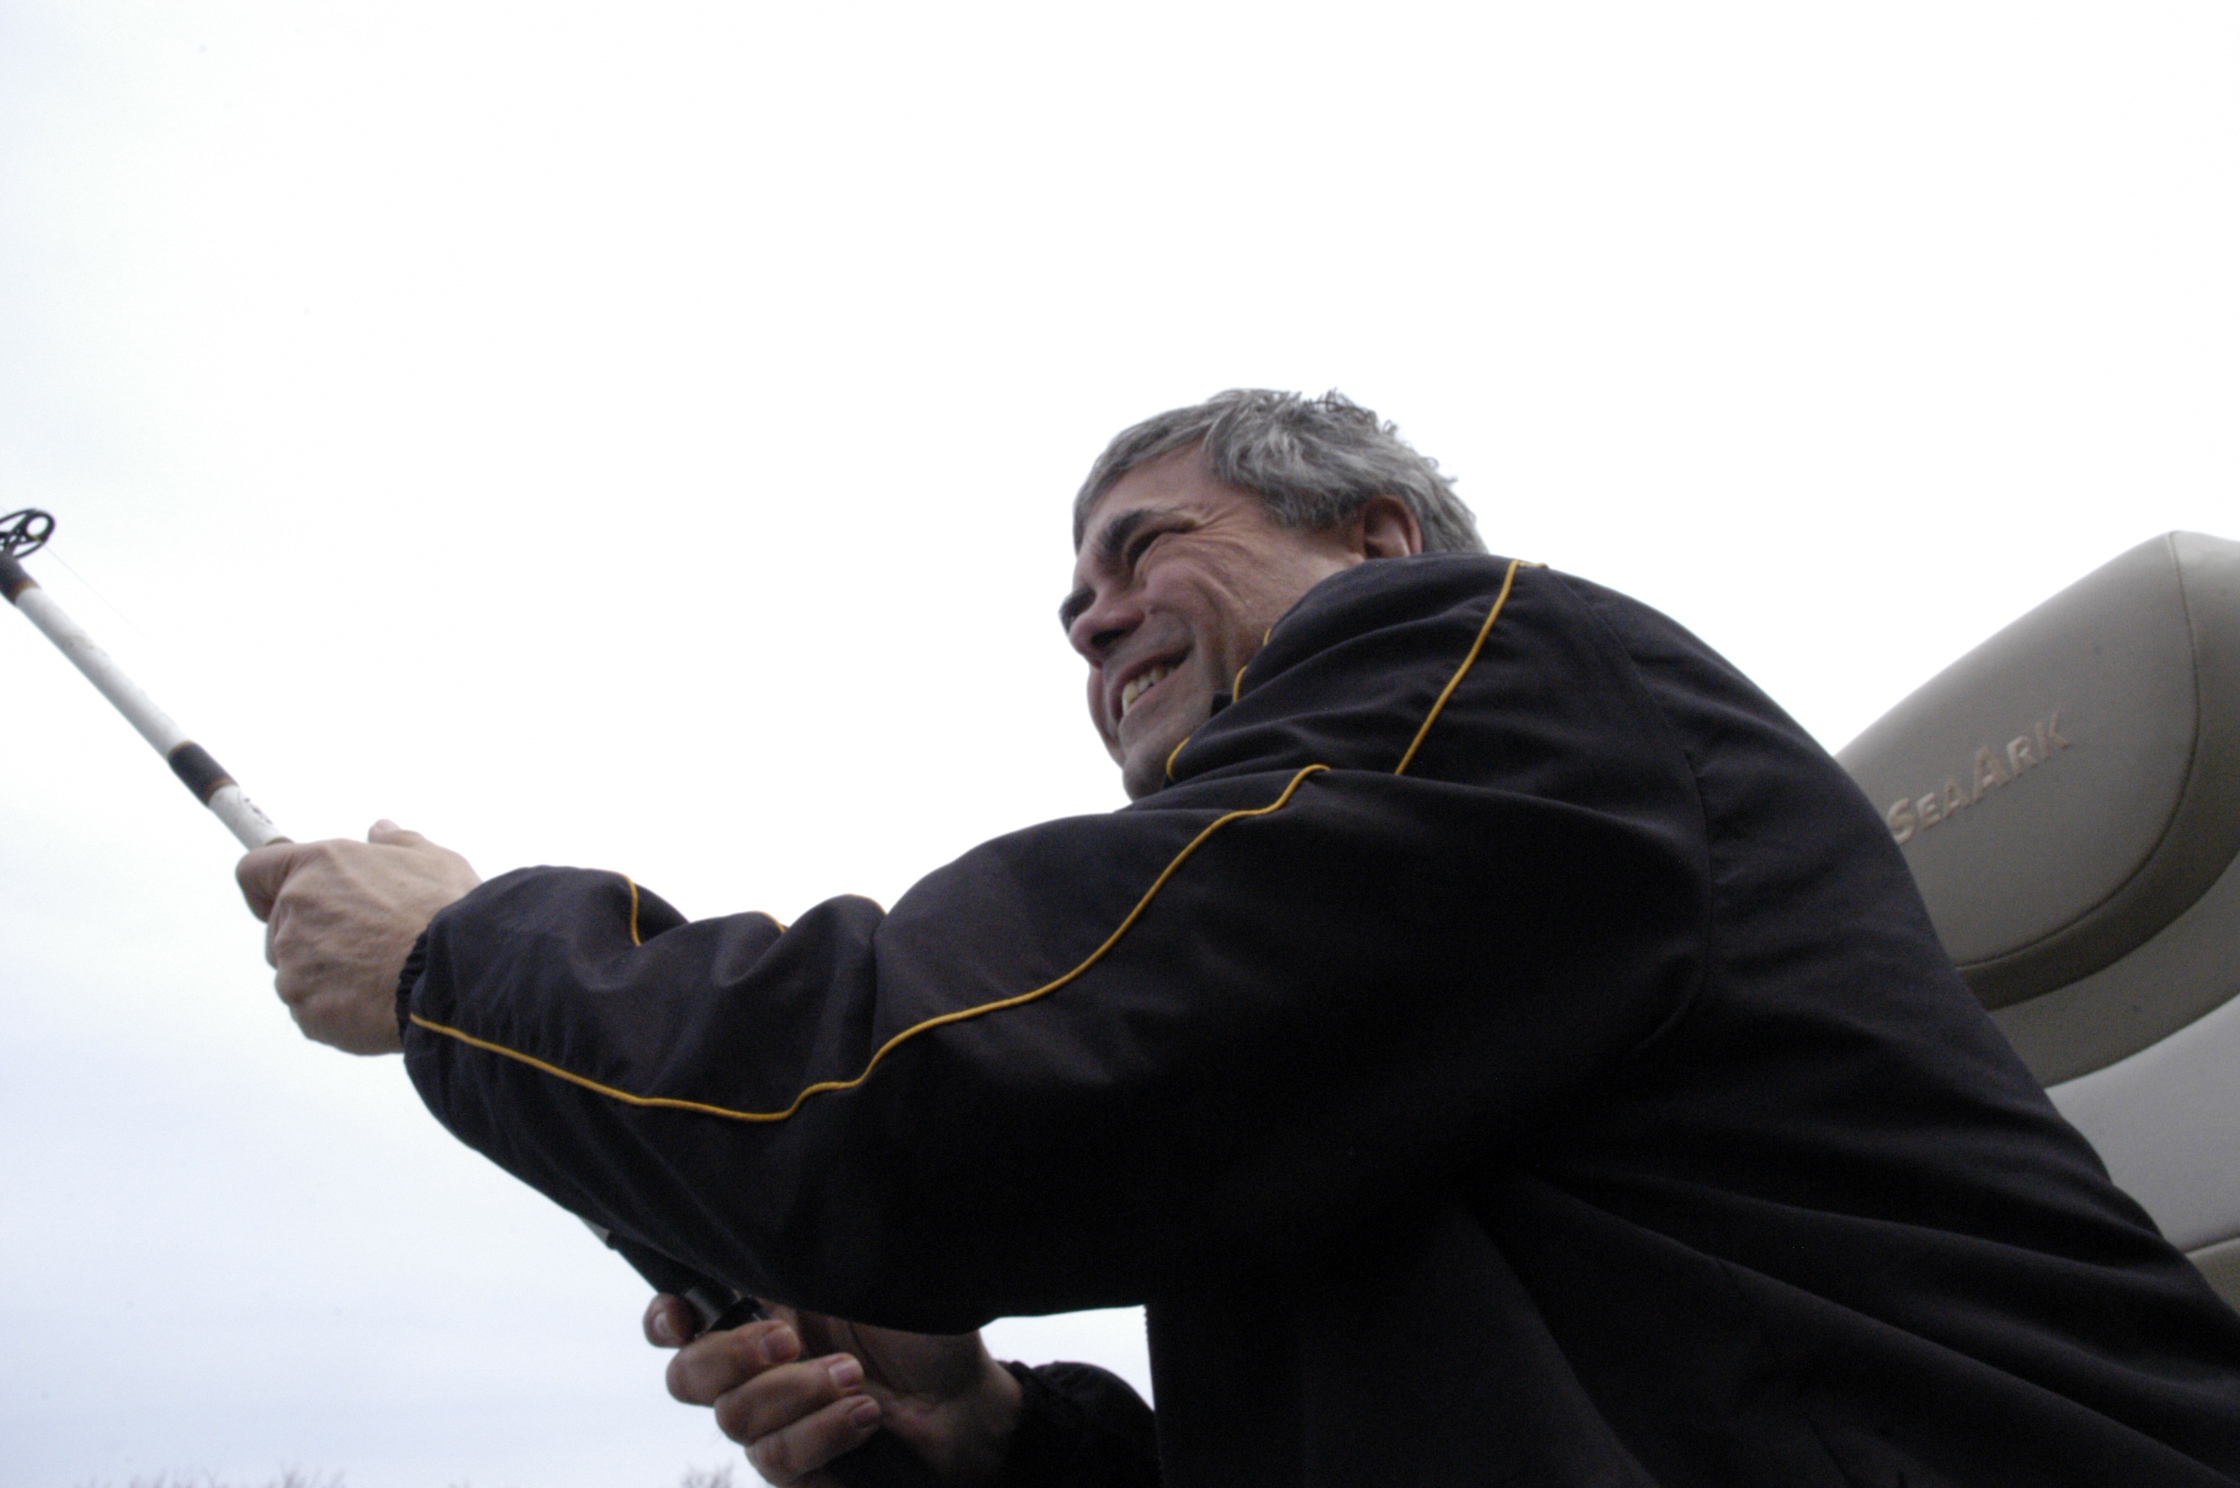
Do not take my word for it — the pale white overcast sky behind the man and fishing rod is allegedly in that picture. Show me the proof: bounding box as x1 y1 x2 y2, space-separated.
0 0 2240 1488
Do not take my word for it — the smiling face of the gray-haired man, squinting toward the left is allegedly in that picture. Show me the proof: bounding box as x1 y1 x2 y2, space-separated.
1057 448 1362 798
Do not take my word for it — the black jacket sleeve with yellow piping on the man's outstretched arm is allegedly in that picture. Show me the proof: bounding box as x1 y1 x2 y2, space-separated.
401 565 1702 1331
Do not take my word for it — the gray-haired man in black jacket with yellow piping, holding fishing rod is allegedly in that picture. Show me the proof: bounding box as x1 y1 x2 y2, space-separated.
242 392 2240 1488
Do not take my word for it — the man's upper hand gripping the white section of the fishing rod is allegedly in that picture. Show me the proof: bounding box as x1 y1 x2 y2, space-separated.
233 820 482 1053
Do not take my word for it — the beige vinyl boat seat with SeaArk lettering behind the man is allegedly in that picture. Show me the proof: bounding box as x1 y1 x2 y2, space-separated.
1837 533 2240 1306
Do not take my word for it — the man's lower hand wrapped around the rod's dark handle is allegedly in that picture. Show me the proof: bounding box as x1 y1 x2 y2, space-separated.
645 1295 1019 1488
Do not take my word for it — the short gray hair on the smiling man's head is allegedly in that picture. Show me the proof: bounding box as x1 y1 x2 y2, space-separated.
1073 388 1485 554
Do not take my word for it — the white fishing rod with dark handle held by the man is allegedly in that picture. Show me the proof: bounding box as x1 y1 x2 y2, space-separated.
0 506 925 1488
